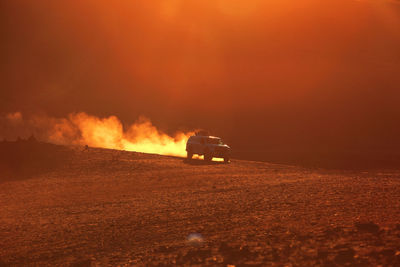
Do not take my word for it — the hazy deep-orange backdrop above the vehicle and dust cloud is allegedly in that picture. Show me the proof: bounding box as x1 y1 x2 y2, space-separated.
0 0 400 151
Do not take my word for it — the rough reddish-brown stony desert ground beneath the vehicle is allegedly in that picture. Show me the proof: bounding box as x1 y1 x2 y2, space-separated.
0 141 400 266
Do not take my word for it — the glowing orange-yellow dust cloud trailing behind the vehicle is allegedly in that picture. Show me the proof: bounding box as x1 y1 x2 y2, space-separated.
0 112 193 157
